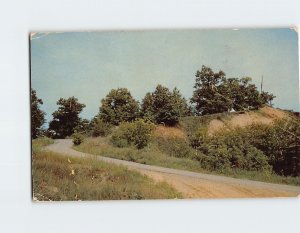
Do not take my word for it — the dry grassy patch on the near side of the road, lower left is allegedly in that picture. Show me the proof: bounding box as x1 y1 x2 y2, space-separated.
32 139 182 201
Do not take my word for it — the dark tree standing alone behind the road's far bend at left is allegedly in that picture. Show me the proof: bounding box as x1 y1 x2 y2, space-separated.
49 96 85 138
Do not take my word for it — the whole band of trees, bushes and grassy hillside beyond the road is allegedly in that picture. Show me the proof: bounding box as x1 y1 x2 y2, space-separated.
32 66 300 189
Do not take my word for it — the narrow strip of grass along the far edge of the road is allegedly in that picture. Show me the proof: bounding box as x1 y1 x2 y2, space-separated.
73 137 300 185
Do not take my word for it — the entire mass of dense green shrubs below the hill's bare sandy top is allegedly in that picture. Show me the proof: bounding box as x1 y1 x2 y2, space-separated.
190 121 300 176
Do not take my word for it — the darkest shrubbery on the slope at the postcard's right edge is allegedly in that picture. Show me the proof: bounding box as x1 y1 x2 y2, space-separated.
241 120 300 176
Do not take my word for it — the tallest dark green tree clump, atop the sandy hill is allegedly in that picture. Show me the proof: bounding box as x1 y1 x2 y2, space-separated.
191 66 275 115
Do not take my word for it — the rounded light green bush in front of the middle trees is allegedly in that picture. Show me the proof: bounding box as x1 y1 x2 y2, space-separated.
111 119 154 149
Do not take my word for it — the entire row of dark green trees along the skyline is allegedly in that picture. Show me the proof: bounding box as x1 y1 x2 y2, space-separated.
31 66 275 138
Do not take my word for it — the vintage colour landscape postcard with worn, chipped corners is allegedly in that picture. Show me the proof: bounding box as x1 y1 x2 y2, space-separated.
30 28 300 201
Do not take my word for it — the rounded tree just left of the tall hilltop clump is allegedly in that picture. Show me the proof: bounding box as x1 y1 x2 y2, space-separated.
142 85 191 125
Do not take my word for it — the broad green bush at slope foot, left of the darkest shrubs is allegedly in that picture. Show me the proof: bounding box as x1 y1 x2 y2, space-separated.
191 126 271 171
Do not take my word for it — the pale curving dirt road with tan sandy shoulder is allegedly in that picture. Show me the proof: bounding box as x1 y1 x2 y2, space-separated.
46 139 300 198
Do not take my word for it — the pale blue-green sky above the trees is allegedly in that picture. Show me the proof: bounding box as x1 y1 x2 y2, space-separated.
31 28 299 122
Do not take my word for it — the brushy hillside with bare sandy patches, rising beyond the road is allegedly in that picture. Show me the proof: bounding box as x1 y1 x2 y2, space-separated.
74 107 300 185
